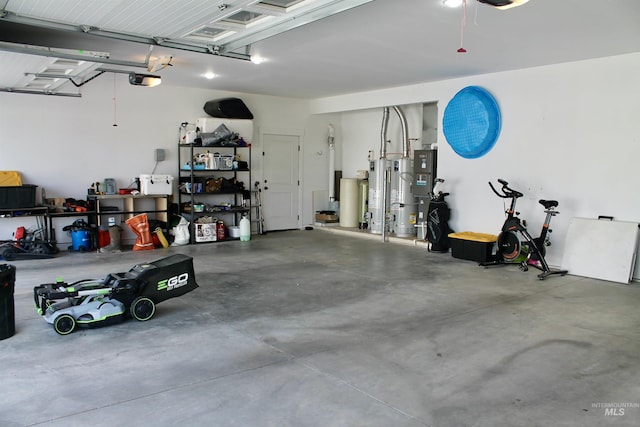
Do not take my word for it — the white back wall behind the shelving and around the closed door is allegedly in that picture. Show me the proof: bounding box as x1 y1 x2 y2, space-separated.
0 74 335 247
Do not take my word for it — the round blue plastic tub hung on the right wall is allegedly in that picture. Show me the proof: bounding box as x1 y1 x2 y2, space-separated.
442 86 501 159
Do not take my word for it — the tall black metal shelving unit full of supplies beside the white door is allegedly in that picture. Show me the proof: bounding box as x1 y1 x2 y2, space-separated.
178 143 251 243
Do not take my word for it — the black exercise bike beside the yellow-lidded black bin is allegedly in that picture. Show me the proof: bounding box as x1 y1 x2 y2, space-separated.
480 179 567 280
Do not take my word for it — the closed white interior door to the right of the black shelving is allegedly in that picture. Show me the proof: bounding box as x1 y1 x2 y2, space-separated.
261 134 300 231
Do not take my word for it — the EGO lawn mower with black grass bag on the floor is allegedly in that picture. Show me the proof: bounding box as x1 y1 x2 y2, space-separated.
33 254 198 335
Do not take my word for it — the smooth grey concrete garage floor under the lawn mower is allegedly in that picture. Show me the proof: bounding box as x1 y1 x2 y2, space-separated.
0 230 640 427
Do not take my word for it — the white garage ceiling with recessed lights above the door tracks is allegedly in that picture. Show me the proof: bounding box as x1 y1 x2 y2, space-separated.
0 0 640 98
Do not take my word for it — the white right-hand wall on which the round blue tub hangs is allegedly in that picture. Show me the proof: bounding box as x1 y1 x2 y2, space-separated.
311 53 640 276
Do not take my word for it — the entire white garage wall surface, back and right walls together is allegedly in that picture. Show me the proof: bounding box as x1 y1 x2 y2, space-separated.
0 53 640 276
